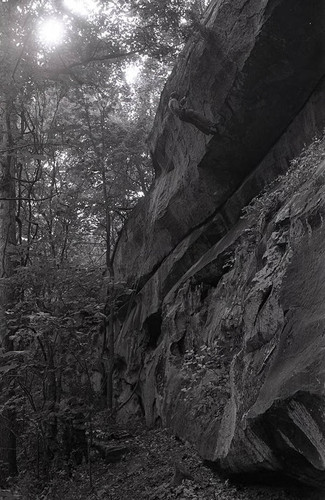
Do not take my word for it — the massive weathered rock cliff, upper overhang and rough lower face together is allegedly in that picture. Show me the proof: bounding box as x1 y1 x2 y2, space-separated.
110 0 325 487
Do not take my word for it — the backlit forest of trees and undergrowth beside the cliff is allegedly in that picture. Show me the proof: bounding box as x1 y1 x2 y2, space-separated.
0 0 208 498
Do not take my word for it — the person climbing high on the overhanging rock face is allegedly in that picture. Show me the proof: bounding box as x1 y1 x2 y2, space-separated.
168 92 218 135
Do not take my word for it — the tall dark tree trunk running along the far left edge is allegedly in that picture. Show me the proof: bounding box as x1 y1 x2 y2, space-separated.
0 3 26 481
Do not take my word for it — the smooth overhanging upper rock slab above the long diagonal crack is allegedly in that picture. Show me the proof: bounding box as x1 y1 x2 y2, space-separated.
115 0 325 290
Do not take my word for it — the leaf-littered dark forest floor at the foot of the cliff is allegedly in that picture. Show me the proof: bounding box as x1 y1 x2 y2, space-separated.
5 414 325 500
